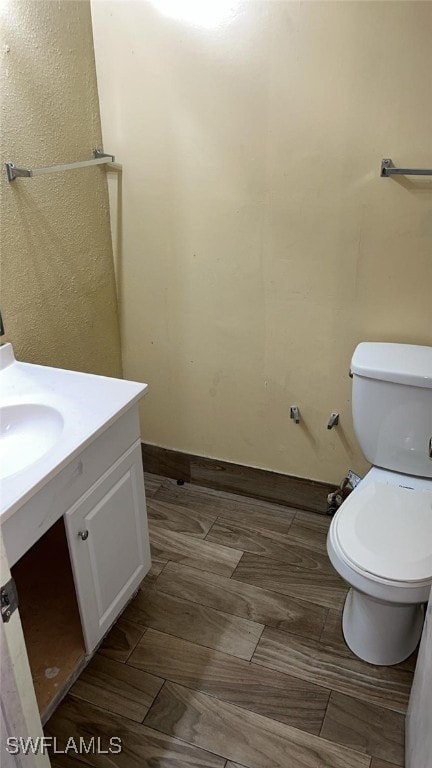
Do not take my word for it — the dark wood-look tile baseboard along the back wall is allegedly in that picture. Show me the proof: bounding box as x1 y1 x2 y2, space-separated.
142 443 335 514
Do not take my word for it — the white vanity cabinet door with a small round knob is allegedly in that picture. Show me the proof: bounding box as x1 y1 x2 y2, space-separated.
65 441 150 653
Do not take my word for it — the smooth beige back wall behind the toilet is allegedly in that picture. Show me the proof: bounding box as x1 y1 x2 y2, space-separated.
92 0 432 481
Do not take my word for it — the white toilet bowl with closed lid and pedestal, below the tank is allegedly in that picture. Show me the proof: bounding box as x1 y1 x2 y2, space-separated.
327 468 432 665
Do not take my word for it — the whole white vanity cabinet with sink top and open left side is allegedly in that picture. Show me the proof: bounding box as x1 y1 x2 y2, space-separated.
0 344 151 722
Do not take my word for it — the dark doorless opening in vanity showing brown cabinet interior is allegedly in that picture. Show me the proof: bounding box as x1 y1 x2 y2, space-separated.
11 518 85 721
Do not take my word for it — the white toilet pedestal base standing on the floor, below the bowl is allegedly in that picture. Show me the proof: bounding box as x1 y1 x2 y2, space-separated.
342 588 424 666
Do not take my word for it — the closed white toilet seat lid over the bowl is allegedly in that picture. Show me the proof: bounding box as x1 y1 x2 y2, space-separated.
335 482 432 582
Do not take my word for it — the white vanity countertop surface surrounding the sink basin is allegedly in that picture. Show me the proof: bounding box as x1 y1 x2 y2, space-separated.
0 344 147 522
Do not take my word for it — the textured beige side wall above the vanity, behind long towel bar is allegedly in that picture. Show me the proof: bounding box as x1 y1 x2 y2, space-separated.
0 0 121 375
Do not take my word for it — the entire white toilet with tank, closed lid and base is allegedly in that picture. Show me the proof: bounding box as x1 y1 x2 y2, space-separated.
327 342 432 665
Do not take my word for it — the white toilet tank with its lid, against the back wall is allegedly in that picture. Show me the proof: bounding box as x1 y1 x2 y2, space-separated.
351 342 432 477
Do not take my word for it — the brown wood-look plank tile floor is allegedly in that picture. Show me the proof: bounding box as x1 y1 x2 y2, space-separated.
46 475 415 768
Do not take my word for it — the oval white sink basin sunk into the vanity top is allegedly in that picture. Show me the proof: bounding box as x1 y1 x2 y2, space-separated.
0 403 63 478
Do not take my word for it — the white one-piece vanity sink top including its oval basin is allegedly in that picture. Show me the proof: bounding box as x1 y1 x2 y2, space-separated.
0 343 147 526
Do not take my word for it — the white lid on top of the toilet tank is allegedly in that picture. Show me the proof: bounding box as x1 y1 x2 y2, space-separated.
351 341 432 389
